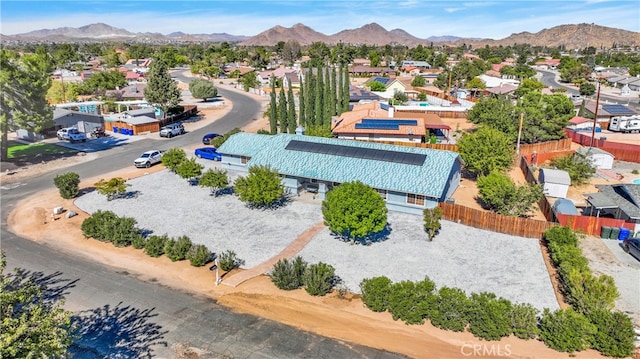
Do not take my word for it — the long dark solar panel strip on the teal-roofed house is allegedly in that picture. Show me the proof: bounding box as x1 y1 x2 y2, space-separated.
285 140 427 166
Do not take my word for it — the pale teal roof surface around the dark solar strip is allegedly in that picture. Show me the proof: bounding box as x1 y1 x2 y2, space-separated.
218 133 461 198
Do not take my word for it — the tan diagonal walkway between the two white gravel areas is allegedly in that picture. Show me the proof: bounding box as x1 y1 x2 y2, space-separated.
222 222 325 288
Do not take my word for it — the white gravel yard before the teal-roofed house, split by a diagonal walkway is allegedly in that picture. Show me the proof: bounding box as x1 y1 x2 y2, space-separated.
75 160 558 309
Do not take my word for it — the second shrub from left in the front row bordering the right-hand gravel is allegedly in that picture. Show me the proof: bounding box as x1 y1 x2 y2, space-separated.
387 278 436 324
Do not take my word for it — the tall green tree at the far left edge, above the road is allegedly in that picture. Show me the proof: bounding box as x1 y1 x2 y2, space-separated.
0 48 54 161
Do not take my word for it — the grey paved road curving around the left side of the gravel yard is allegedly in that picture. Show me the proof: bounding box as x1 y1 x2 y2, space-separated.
0 78 402 358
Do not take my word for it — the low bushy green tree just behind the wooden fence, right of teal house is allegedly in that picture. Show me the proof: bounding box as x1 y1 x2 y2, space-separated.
478 171 543 217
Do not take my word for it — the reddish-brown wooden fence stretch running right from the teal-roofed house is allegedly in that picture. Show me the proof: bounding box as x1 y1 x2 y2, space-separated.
438 202 556 238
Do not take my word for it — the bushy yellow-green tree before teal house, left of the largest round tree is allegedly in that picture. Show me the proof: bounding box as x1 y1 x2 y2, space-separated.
234 166 284 207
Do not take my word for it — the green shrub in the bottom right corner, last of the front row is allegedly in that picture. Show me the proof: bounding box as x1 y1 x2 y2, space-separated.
588 310 635 358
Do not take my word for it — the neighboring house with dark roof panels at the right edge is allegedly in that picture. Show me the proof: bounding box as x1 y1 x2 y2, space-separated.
587 184 640 232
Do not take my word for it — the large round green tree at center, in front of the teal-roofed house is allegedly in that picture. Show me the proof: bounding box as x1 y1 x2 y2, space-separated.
322 181 387 243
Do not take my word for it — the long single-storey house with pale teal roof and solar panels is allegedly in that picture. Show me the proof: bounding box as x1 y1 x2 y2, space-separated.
218 132 462 214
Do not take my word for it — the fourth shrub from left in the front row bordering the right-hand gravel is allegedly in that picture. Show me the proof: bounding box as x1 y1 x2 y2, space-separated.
468 292 513 340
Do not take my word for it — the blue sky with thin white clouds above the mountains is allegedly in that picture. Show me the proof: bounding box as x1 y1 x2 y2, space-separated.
0 0 640 39
